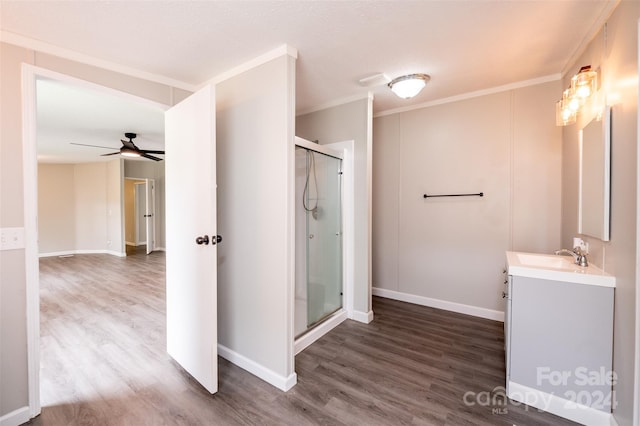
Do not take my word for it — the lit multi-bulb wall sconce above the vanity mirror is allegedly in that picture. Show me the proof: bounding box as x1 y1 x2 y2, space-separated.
556 65 598 126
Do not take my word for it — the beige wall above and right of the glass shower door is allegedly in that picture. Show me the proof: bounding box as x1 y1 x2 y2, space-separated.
296 97 373 322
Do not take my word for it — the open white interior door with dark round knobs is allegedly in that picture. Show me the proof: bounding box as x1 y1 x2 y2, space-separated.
165 86 218 393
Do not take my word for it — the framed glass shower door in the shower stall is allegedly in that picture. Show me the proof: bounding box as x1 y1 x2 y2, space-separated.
303 150 343 327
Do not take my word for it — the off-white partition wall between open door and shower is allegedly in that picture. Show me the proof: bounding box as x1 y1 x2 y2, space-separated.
216 56 296 389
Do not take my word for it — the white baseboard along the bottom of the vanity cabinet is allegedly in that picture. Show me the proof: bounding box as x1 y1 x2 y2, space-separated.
507 381 615 426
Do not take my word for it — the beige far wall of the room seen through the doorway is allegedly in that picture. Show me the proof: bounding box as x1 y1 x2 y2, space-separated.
38 160 124 256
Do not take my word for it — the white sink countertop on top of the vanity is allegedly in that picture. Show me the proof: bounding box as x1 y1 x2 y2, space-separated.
507 251 616 287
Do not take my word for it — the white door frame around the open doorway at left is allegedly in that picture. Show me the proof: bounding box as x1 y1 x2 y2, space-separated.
21 63 170 418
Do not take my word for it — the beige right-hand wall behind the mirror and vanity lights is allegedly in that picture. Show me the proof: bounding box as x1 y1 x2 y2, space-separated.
558 1 640 426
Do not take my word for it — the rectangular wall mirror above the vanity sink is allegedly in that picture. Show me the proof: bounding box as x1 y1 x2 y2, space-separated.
578 107 611 241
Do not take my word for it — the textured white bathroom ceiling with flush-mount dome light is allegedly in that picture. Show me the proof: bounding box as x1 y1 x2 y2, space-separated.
0 0 616 163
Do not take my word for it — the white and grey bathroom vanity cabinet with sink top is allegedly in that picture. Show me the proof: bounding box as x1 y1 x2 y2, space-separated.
505 252 615 425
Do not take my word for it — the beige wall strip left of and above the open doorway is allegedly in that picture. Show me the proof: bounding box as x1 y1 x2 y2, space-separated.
0 43 185 417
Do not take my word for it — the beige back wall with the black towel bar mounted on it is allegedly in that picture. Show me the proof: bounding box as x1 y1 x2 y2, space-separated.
373 82 561 319
